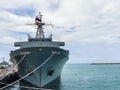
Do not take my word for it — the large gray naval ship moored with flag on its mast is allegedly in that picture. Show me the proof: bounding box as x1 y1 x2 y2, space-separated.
10 13 69 88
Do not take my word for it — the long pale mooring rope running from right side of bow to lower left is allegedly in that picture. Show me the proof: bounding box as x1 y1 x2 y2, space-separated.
0 53 55 90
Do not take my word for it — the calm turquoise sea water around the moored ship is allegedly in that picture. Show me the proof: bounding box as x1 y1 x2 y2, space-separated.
5 64 120 90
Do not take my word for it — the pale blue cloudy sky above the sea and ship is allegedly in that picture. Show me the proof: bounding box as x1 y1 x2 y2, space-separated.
0 0 120 63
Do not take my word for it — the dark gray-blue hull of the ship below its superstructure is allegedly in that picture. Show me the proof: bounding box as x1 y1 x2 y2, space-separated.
10 47 69 88
